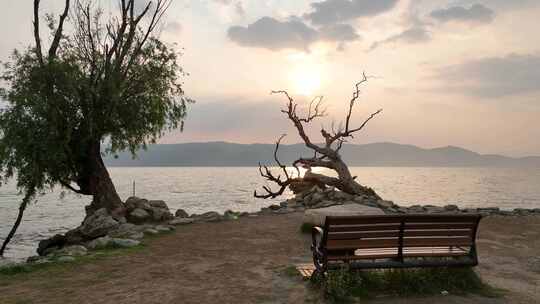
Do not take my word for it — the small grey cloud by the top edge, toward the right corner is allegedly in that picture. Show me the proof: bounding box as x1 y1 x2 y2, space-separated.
430 4 495 24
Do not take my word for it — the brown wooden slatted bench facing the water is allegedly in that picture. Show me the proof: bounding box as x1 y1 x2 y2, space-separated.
311 214 481 275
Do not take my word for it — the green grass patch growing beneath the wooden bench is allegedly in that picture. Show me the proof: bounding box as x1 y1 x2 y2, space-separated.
312 267 503 303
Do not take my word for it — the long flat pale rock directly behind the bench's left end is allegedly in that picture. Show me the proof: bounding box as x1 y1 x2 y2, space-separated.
303 204 384 226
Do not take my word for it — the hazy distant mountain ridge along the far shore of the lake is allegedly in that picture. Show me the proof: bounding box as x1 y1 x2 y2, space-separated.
105 142 540 168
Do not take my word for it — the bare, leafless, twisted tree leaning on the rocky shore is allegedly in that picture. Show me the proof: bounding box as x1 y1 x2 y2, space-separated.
254 73 382 199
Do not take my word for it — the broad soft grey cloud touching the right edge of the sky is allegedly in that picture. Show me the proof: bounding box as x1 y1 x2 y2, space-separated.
436 53 540 98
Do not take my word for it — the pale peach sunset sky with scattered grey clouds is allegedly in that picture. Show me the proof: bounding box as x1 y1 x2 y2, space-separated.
0 0 540 156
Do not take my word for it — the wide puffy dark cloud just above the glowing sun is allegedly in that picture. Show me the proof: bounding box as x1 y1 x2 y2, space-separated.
227 17 360 52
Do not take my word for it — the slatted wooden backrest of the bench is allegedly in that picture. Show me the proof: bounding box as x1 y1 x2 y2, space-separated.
321 214 481 251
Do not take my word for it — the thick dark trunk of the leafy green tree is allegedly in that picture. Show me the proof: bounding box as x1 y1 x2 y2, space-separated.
77 142 125 217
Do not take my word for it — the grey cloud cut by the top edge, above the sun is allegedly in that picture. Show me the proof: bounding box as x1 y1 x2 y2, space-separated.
304 0 397 25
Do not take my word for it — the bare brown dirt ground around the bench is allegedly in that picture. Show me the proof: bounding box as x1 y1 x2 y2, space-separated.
0 213 540 304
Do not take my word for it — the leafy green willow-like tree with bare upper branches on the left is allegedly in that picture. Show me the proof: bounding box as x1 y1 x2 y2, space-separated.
0 0 191 256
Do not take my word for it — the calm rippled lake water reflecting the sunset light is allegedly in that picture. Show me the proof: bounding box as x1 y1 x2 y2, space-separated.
0 167 540 259
